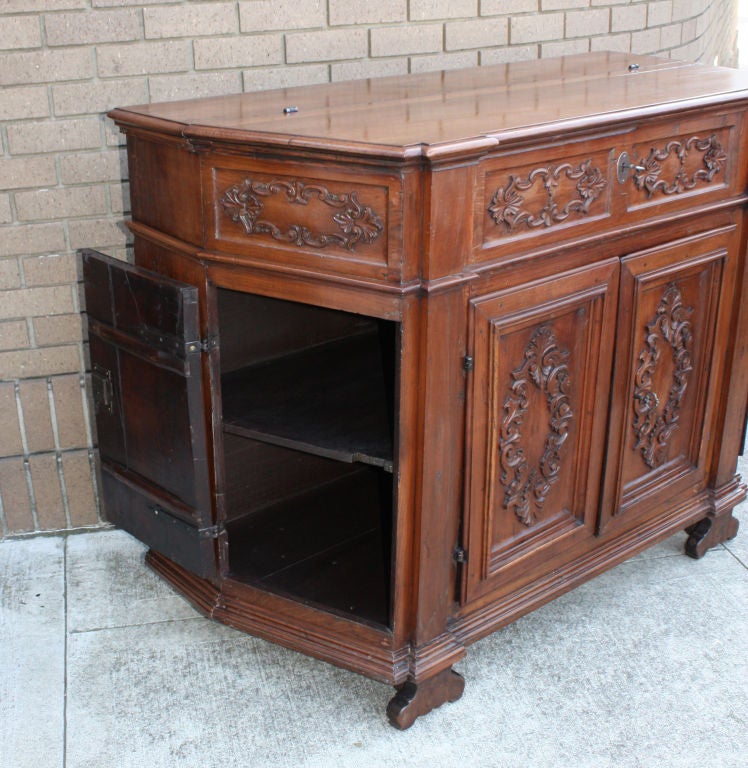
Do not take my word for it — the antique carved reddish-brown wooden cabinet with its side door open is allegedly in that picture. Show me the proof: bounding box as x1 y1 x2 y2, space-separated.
83 54 748 728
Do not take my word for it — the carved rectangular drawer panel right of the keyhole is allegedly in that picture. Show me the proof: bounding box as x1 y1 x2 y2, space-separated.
619 116 740 216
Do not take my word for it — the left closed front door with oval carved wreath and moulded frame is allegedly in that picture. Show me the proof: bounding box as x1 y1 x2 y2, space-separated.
463 259 618 601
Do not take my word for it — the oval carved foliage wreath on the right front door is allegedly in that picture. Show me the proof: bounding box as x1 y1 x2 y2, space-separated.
633 283 693 469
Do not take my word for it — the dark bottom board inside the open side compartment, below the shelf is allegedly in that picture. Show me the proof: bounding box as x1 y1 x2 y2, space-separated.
227 467 392 626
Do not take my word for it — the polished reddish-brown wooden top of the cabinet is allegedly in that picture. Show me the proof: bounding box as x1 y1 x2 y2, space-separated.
110 52 748 158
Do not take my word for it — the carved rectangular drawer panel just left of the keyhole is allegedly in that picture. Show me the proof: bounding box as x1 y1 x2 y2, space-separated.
473 138 616 261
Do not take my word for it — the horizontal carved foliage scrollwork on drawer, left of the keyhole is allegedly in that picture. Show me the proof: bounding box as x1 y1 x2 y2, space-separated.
488 160 608 232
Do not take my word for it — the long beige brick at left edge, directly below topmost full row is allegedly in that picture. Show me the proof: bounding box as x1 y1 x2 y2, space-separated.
0 48 93 85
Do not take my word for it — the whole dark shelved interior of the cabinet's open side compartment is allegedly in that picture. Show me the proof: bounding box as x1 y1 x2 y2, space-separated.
217 289 398 625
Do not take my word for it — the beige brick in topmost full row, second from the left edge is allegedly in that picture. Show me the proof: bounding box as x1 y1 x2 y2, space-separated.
44 9 141 46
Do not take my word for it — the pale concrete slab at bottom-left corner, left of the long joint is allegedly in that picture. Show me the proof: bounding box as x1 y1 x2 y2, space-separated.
0 538 65 768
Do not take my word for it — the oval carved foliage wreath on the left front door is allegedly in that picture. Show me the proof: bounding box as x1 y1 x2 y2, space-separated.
499 325 574 526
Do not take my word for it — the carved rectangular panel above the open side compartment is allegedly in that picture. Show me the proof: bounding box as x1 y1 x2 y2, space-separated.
205 158 402 277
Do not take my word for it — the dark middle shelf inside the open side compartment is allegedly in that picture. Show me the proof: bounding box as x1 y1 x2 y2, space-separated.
222 334 393 472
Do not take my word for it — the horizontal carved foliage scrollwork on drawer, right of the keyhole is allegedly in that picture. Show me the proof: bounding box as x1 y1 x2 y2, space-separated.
634 134 727 197
